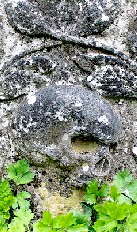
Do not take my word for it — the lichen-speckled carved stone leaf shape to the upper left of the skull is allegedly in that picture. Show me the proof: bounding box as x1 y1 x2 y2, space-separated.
0 53 56 99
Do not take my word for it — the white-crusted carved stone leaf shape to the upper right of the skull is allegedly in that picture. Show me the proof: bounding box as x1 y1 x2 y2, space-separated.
74 53 137 98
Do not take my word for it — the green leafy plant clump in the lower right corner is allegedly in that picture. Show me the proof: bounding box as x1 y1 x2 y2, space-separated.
84 170 137 232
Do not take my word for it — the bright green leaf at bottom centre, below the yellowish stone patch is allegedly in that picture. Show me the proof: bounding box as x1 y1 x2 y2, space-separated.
53 213 76 229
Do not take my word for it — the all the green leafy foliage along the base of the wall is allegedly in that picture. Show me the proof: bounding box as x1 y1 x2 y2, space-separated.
0 159 137 232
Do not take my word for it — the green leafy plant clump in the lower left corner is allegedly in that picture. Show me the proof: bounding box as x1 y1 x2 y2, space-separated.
0 160 34 232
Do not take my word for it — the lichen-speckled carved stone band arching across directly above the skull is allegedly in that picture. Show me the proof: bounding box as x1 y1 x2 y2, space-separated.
0 44 137 99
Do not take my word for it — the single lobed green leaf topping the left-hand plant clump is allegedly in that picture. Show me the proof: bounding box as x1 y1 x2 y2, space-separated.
7 159 34 185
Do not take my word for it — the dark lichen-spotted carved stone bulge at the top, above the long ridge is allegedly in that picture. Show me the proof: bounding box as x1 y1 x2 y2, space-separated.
5 0 120 36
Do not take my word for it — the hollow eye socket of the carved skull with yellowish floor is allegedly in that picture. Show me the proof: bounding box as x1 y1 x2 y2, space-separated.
71 135 99 153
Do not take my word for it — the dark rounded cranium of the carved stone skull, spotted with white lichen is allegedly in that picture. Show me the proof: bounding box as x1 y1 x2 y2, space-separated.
12 86 120 174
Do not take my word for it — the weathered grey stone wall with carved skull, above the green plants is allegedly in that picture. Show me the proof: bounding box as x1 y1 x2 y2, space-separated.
0 0 137 214
